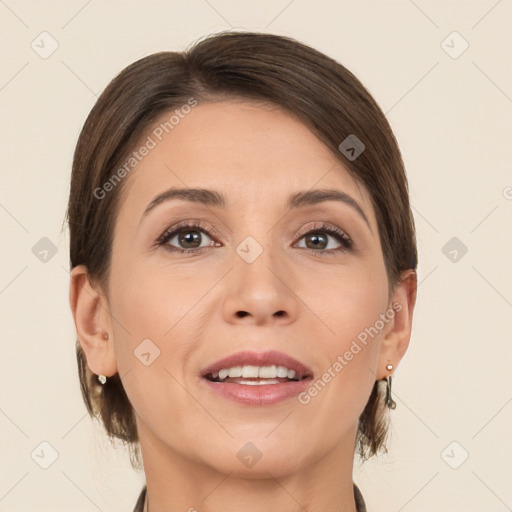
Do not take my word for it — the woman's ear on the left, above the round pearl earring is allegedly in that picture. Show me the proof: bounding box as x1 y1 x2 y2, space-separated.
69 265 117 377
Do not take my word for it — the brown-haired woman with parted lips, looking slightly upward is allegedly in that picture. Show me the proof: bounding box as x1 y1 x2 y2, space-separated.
68 32 417 512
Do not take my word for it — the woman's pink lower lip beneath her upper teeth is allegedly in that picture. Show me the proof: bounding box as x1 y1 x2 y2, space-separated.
201 377 312 406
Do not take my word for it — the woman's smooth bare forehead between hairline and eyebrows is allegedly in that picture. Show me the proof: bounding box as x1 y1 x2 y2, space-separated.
116 100 372 221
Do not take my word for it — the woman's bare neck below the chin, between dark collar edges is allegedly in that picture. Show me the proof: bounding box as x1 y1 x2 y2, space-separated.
139 418 357 512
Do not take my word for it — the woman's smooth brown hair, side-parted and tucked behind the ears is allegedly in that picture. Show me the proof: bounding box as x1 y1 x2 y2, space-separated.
67 28 417 467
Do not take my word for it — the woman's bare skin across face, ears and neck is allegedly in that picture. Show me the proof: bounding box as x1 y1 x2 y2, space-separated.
70 100 416 512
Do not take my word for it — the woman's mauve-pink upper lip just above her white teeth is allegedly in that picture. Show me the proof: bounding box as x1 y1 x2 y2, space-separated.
201 350 313 378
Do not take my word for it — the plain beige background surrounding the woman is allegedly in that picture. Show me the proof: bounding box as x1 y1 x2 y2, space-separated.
0 0 512 512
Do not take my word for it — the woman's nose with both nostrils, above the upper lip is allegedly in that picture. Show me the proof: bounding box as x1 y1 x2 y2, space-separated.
223 242 299 325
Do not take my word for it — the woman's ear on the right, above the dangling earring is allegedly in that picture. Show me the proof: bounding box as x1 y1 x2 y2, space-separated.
377 269 418 380
